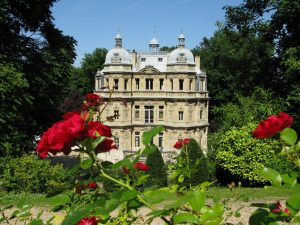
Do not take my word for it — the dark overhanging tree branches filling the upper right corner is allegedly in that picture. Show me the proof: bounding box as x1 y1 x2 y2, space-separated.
225 0 300 126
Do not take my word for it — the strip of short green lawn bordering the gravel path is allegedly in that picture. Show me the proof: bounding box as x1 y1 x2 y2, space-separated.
0 184 300 207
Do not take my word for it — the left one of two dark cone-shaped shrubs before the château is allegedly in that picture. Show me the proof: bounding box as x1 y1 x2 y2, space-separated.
146 147 168 187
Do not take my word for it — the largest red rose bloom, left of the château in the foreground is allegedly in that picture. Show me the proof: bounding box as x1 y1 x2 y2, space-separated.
36 112 85 158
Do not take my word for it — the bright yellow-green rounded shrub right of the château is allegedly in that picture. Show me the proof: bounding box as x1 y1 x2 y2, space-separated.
216 123 294 185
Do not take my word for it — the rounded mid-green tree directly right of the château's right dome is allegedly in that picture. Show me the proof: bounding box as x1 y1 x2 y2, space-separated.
194 24 273 105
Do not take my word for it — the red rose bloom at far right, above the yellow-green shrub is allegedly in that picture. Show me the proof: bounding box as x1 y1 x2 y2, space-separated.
252 112 294 138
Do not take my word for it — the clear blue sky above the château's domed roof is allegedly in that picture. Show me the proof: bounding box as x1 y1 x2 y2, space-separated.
52 0 242 66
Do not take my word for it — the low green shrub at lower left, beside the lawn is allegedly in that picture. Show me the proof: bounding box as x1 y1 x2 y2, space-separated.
1 155 64 193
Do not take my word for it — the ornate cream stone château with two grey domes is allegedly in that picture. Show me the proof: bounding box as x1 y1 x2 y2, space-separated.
95 34 209 161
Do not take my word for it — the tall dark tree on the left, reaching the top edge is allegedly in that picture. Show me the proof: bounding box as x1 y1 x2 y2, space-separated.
0 0 76 154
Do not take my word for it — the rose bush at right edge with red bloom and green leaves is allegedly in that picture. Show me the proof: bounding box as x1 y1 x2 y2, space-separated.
249 112 300 225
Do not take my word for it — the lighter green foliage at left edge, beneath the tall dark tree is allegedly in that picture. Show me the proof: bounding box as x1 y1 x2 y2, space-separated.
0 62 32 156
